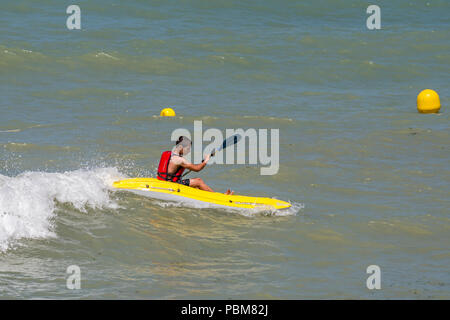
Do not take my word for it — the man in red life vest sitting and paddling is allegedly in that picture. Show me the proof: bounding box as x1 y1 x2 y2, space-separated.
157 136 234 194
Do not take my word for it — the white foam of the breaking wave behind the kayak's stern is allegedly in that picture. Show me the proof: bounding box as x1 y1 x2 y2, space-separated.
0 168 124 252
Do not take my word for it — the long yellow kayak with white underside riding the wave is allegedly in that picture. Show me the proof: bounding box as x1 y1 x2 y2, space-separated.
113 178 291 209
